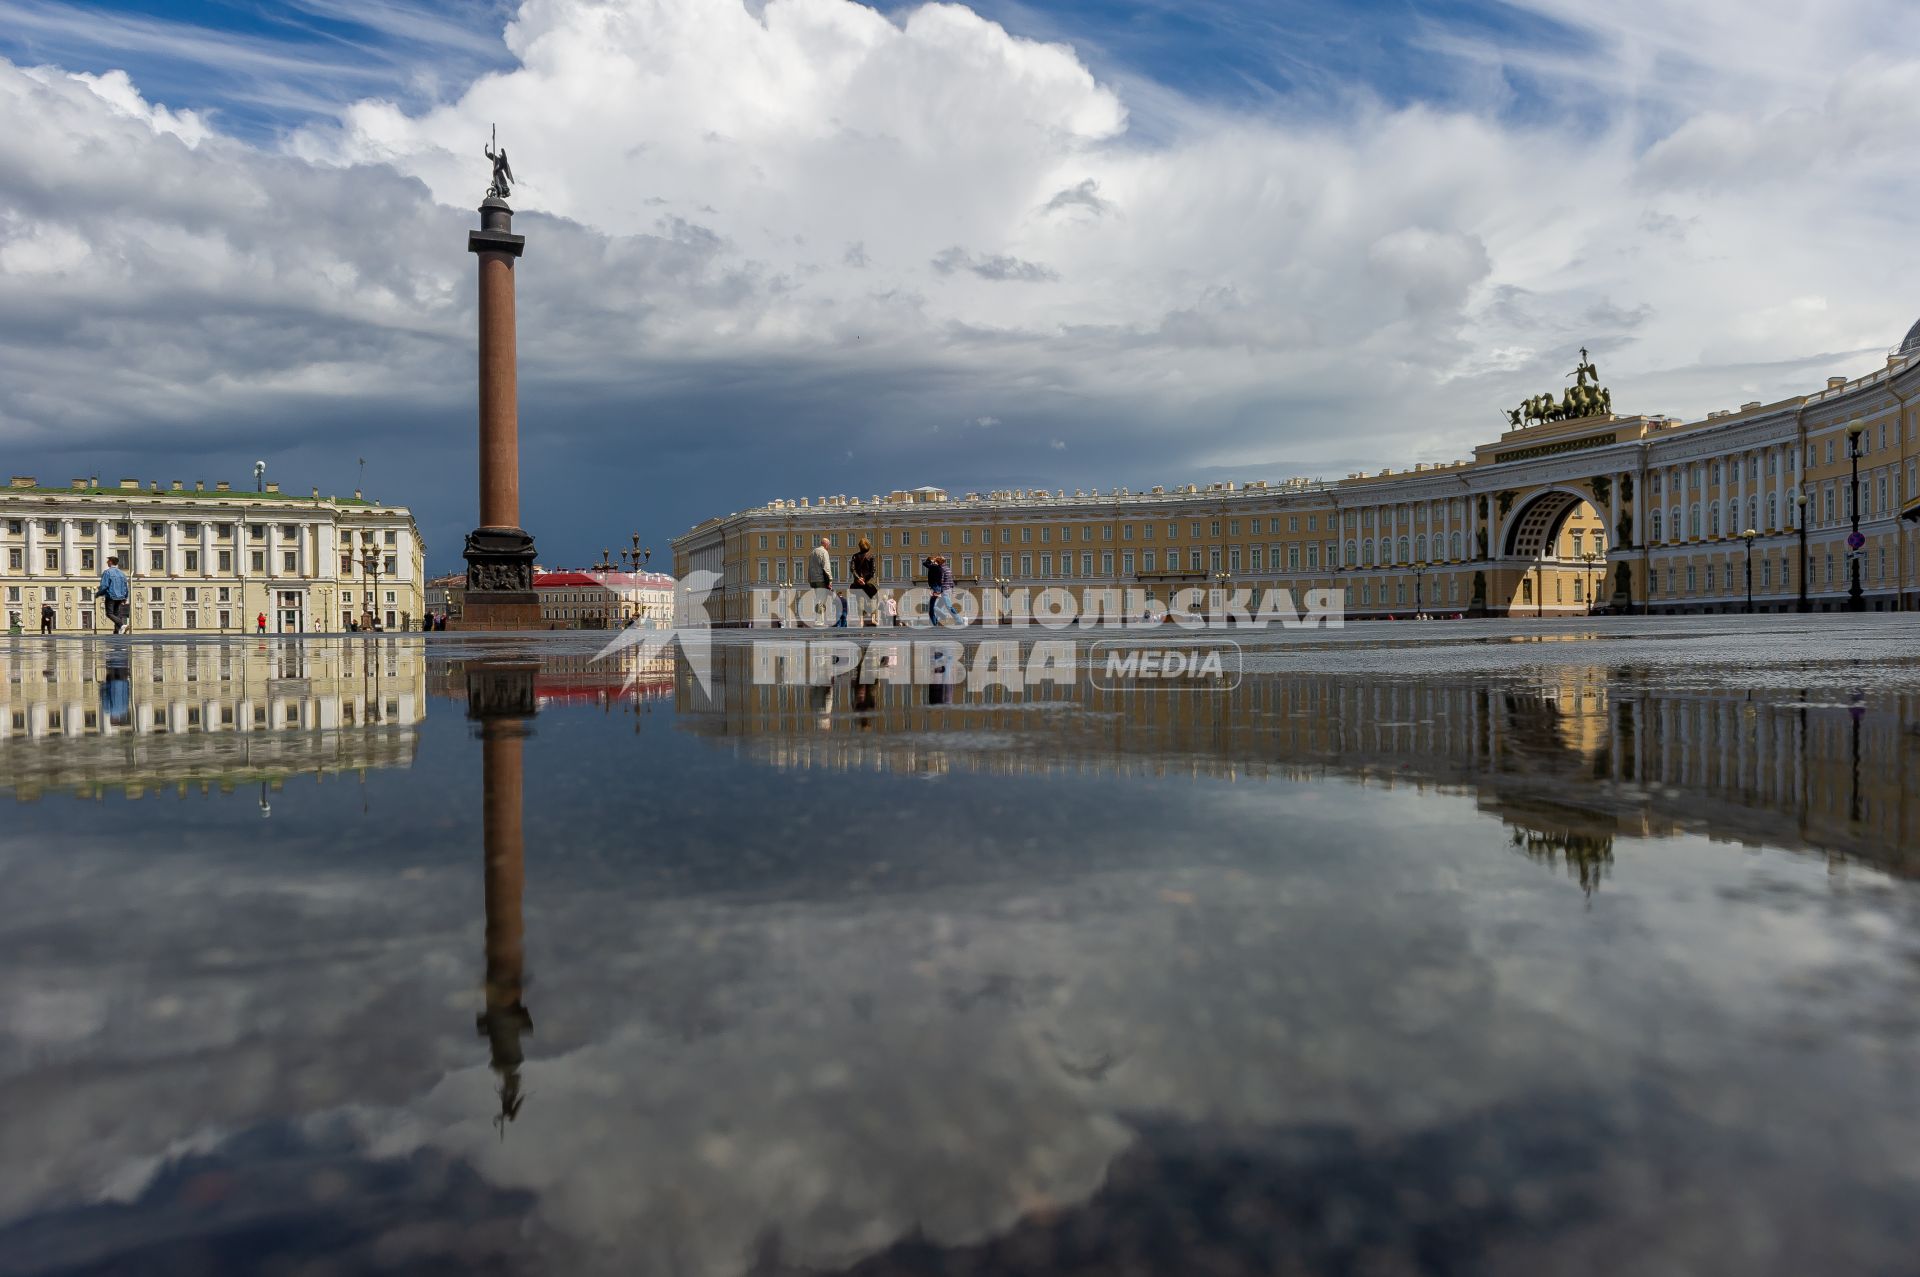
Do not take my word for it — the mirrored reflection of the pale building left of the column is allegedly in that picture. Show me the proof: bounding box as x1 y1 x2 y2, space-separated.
0 638 426 799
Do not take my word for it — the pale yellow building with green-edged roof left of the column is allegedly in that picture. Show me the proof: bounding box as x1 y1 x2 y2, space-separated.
0 474 426 634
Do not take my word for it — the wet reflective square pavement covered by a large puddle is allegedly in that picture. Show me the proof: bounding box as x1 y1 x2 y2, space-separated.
0 616 1920 1277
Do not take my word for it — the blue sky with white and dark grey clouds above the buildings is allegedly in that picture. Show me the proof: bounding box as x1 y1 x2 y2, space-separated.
0 0 1920 568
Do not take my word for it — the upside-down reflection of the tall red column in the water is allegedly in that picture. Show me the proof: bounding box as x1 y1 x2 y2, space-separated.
467 663 534 1131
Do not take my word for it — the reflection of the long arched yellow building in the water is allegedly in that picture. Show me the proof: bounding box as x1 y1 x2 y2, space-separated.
676 649 1920 883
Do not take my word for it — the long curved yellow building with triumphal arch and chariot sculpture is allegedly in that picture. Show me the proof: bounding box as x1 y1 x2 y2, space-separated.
674 334 1920 624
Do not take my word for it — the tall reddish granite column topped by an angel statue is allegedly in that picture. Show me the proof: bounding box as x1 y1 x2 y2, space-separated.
455 128 540 630
